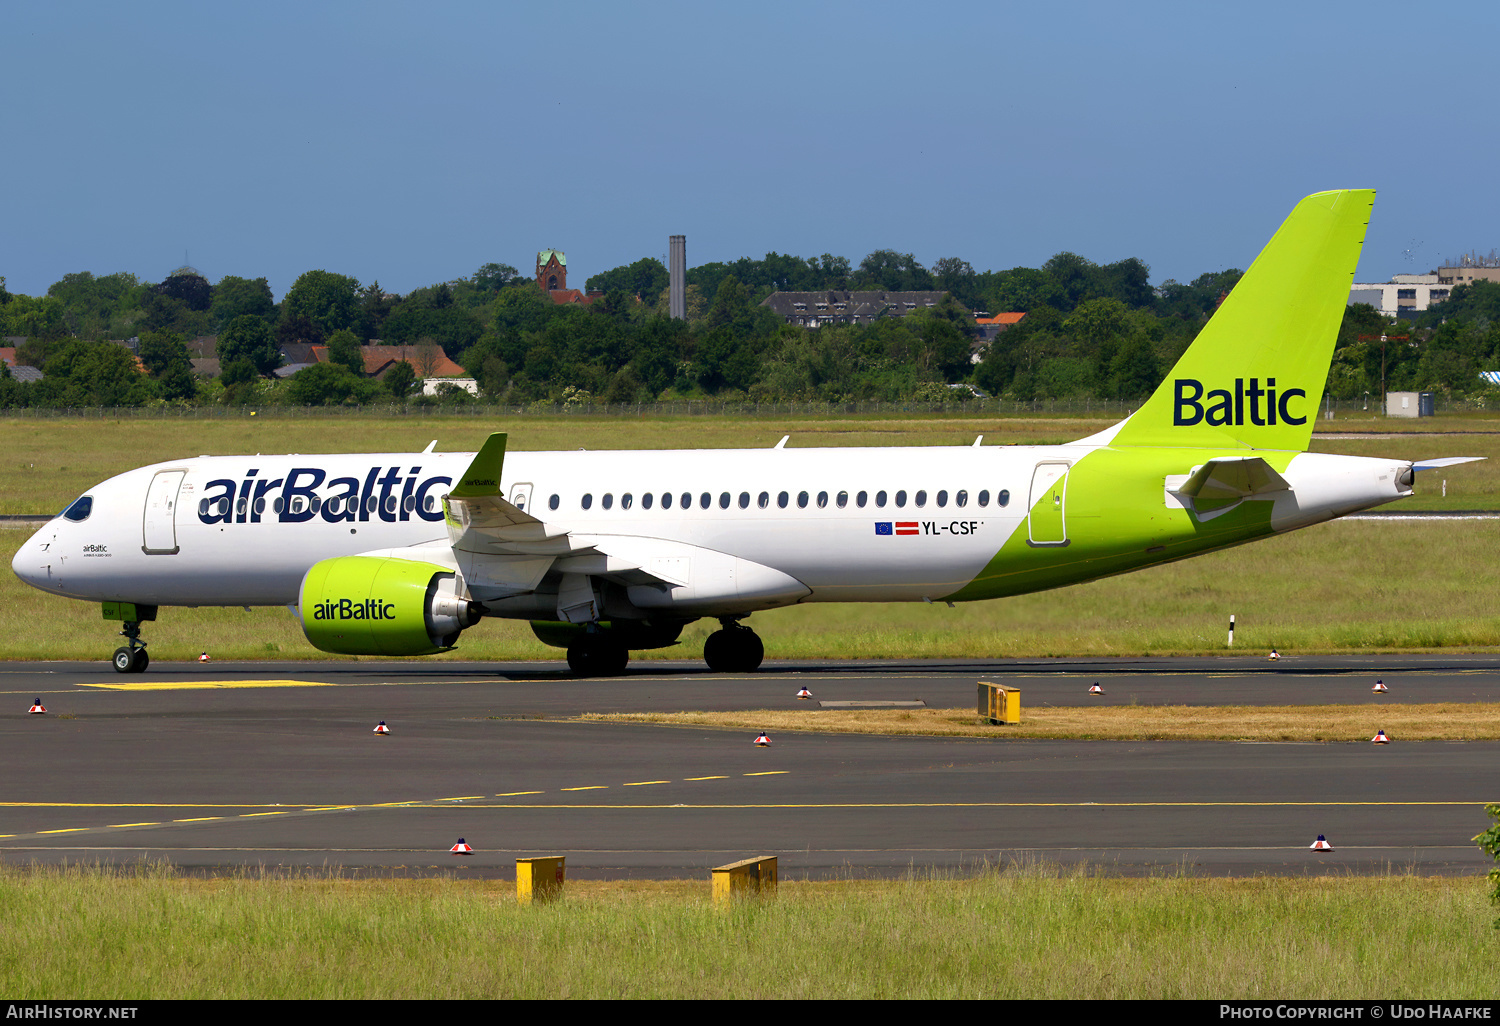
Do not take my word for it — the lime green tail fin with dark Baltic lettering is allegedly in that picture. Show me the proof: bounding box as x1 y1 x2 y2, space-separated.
1110 189 1376 452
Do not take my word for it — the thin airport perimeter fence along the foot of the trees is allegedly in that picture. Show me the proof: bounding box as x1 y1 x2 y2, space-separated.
0 395 1500 423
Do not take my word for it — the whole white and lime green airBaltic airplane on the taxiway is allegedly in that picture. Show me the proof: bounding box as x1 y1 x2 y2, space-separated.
12 191 1488 675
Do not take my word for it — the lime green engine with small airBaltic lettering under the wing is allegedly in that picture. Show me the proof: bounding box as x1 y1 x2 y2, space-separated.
297 557 480 656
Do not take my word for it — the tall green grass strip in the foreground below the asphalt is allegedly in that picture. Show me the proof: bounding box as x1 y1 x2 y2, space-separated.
0 866 1500 1001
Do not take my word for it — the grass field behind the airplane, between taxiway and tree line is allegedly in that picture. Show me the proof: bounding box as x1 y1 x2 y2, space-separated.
0 417 1500 660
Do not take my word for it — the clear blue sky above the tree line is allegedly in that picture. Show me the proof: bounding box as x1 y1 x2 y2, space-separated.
0 0 1500 299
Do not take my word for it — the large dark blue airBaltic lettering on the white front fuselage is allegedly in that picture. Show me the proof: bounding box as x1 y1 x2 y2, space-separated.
198 467 453 524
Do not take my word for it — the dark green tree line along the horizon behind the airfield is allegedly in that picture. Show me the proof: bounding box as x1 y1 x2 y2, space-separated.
0 243 1500 407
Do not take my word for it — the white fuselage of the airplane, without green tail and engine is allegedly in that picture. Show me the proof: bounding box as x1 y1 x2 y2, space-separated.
12 444 1409 618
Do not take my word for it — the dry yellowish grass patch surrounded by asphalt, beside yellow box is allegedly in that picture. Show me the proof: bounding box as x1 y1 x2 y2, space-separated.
579 702 1500 741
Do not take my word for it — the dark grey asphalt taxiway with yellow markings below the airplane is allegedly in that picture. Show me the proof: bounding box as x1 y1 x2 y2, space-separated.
0 654 1500 879
